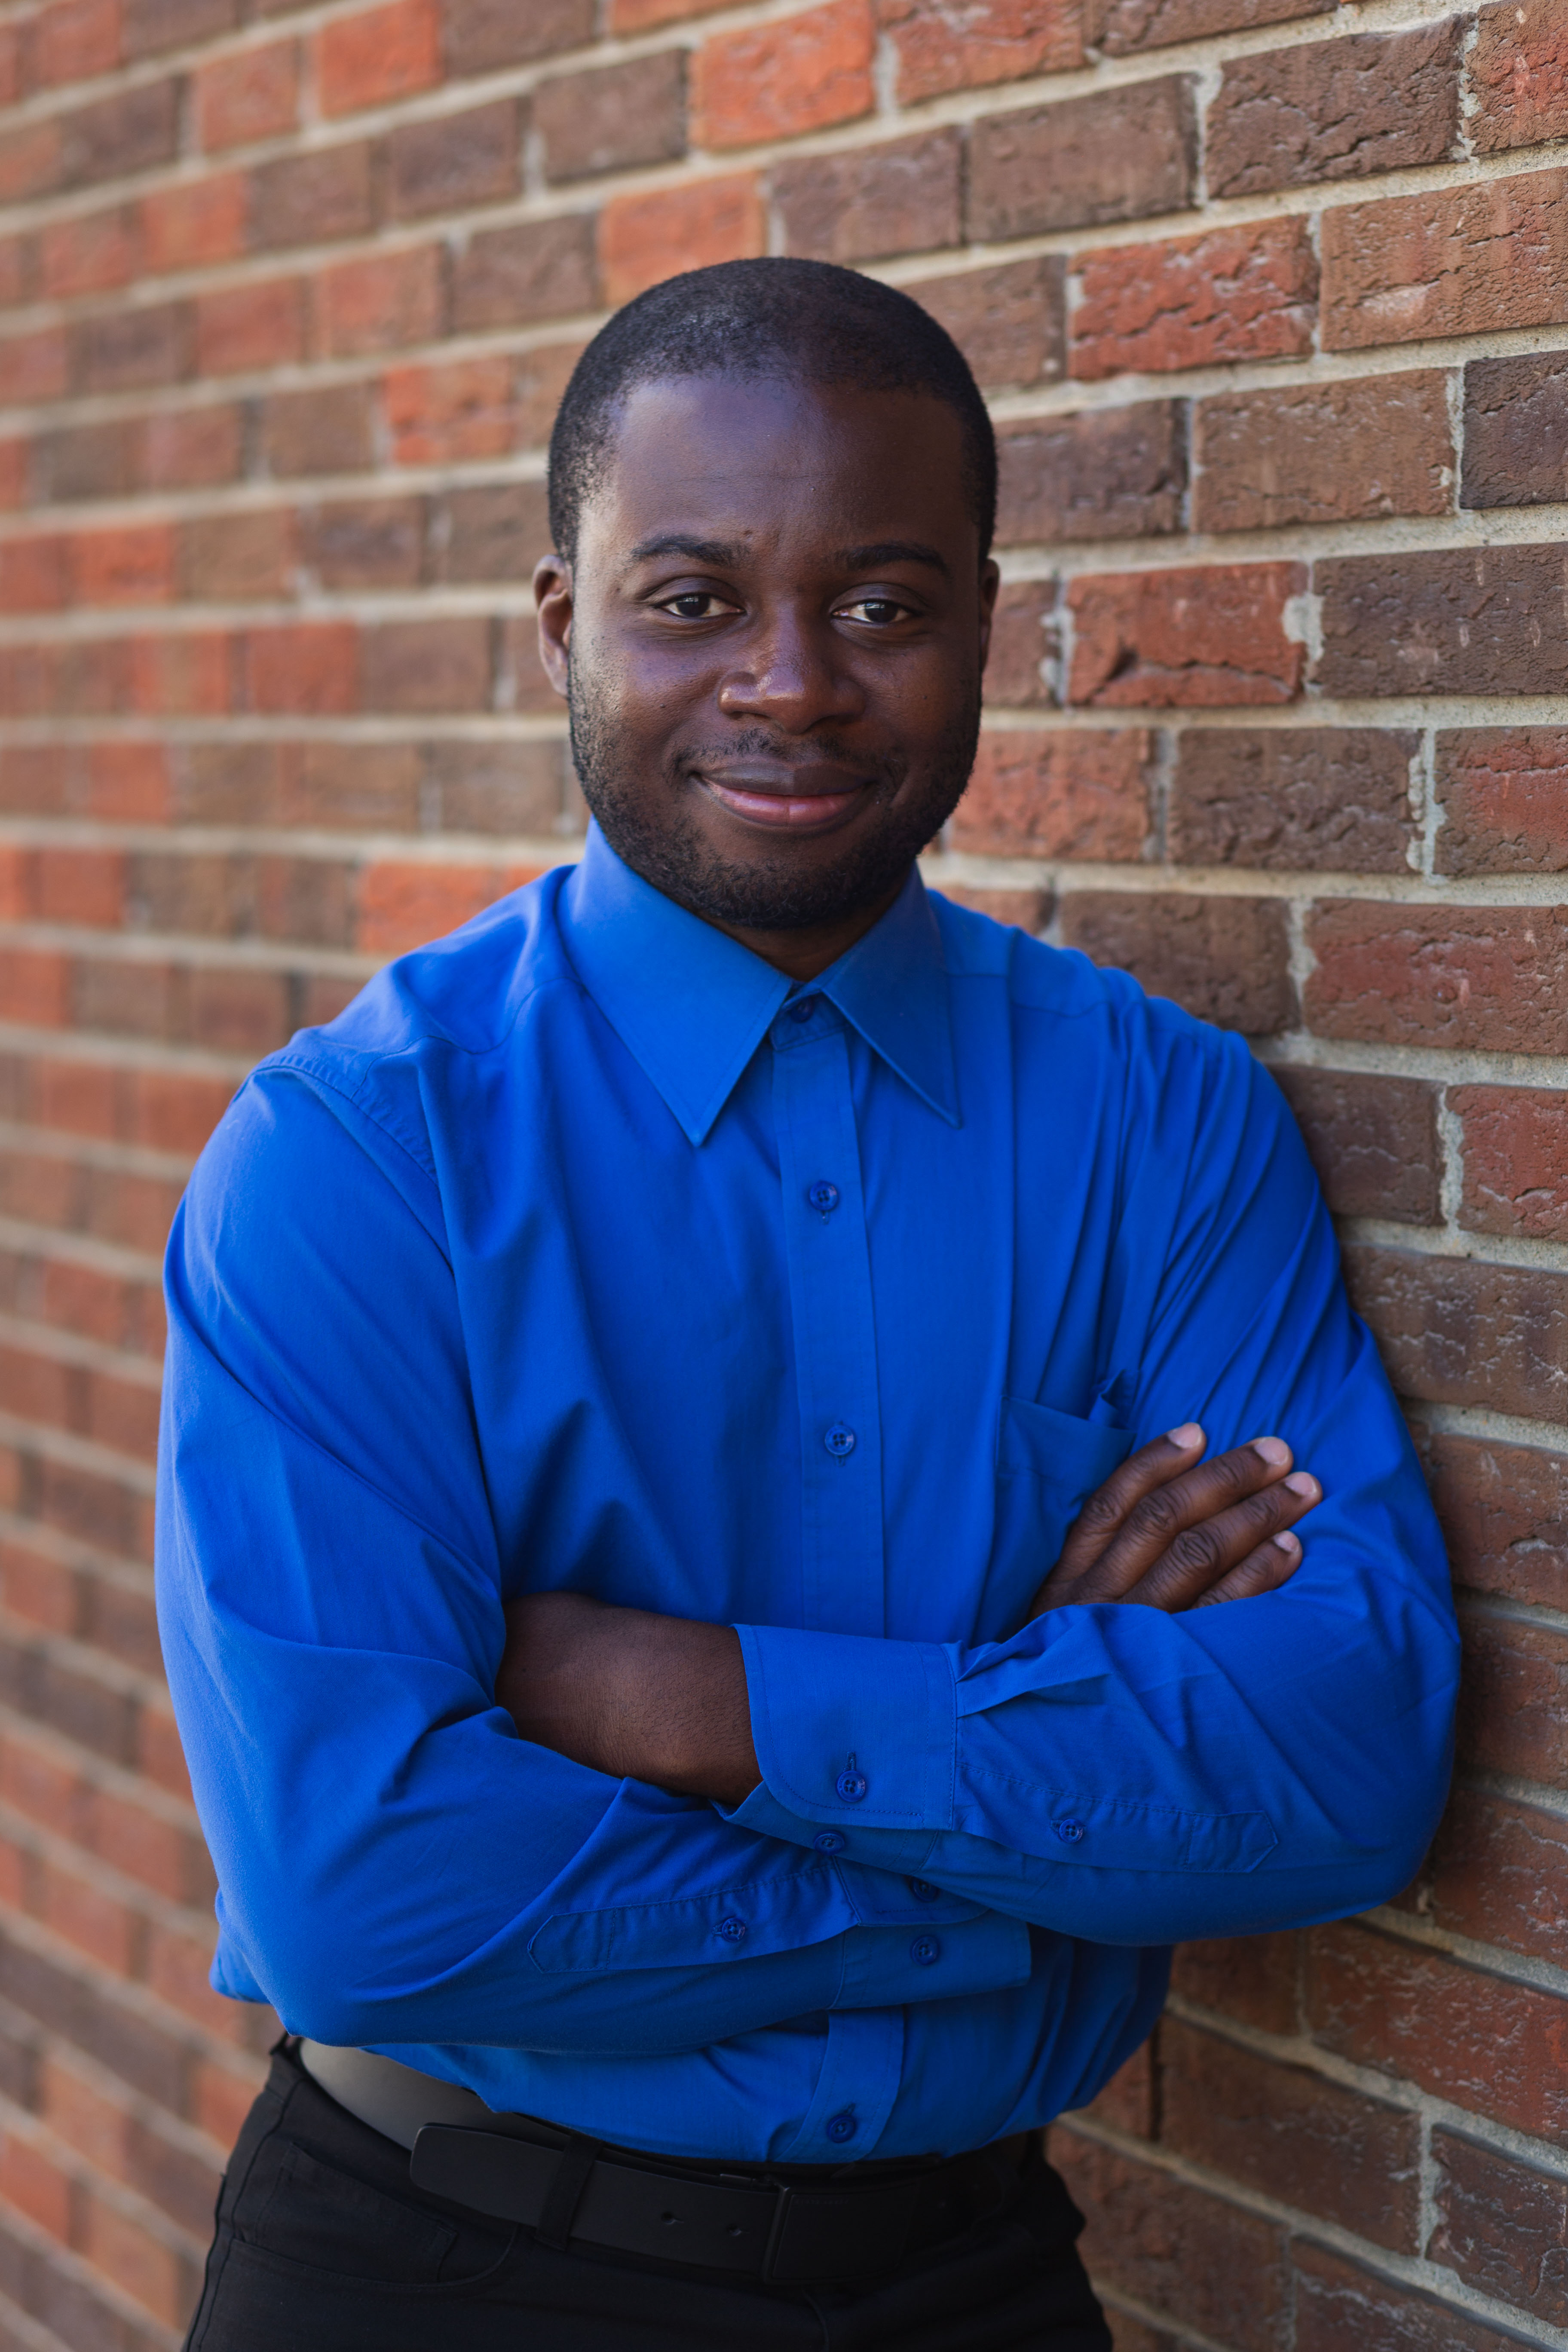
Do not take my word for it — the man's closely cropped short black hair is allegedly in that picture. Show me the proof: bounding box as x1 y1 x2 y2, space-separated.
550 259 997 557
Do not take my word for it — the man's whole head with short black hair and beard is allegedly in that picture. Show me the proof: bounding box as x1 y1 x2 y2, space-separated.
536 261 997 969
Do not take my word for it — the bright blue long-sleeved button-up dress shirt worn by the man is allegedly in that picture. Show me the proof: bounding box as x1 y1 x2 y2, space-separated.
160 833 1455 2162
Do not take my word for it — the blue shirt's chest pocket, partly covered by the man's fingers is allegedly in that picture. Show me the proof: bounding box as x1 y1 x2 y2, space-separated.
985 1397 1133 1639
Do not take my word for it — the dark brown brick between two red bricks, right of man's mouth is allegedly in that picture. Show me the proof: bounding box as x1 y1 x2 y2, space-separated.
1166 727 1420 873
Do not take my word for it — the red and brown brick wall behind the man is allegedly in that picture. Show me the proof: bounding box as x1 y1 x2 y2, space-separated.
0 0 1568 2352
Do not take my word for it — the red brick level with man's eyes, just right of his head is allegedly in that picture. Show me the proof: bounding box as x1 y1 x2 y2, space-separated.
1067 564 1307 710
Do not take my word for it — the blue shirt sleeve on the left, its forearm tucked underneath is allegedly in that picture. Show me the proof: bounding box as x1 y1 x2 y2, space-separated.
157 1066 1030 2053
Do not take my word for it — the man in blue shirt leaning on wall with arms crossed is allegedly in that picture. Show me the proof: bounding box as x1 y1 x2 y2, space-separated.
160 261 1453 2352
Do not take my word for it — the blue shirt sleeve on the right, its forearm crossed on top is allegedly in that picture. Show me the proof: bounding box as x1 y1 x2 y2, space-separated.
726 1040 1458 1945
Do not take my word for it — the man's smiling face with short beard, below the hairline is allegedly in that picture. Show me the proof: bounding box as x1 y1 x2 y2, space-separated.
536 377 997 931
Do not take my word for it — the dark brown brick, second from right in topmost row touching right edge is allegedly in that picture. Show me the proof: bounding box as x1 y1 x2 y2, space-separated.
1204 19 1462 195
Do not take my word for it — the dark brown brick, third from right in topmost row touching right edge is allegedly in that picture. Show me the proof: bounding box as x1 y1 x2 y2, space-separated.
968 73 1194 238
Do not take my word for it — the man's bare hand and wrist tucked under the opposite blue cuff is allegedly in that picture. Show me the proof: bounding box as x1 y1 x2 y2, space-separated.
496 1592 762 1804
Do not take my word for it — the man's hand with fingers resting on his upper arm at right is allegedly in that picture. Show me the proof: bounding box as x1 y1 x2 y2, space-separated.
1030 1421 1323 1618
